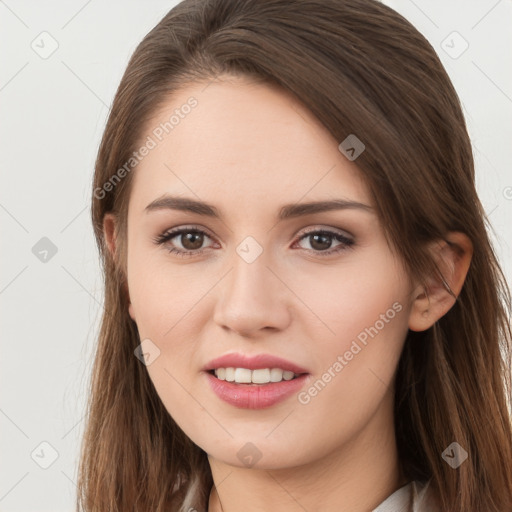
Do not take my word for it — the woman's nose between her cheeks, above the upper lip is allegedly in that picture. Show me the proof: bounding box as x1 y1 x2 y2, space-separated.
213 247 293 337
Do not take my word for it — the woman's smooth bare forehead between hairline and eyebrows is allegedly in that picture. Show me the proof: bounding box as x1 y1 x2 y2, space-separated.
130 78 370 217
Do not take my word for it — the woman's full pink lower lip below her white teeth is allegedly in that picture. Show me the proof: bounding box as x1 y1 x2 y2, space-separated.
205 372 309 409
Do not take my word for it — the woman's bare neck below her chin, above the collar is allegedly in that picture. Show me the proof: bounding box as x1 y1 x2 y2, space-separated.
208 388 407 512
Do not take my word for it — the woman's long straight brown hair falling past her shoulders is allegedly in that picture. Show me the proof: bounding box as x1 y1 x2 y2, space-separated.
77 0 512 512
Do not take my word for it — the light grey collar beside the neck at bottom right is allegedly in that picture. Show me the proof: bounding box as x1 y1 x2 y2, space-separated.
372 480 439 512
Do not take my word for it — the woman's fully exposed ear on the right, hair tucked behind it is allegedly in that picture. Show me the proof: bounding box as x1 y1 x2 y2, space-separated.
409 231 473 331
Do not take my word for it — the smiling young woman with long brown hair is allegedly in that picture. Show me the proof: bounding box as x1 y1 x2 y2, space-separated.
78 0 512 512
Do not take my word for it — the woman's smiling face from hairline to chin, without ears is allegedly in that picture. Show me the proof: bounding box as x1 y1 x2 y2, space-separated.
121 78 411 468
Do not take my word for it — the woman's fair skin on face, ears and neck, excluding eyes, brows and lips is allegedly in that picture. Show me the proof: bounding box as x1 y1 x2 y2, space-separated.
104 77 472 512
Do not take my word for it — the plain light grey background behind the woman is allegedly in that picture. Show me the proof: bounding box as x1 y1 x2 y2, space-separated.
0 0 512 512
